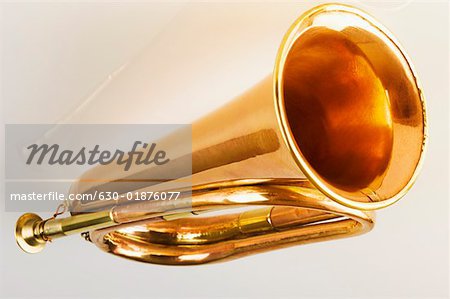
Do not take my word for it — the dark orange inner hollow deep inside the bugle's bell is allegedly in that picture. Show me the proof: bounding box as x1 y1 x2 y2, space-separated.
284 27 393 192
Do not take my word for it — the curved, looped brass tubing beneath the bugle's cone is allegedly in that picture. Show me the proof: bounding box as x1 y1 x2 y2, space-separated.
90 182 374 265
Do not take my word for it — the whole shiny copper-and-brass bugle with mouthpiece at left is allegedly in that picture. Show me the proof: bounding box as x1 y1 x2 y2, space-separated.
16 4 427 265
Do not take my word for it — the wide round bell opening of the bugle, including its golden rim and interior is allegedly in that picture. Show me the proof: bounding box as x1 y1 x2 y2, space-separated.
273 5 426 209
